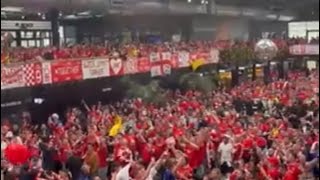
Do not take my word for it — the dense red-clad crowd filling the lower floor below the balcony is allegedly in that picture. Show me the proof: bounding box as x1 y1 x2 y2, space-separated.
1 68 319 180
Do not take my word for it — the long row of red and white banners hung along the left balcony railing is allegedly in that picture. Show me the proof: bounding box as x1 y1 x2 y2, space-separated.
1 49 219 90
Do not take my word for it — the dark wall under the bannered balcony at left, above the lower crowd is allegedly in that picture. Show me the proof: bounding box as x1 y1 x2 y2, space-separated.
1 78 125 121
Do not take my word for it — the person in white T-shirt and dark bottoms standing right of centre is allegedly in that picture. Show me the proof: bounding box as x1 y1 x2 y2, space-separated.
218 136 233 175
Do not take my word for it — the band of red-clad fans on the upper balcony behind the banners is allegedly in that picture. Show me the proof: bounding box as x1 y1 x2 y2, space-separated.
1 38 319 63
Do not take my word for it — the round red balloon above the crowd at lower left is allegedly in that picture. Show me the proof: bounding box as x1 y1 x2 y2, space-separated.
4 144 30 165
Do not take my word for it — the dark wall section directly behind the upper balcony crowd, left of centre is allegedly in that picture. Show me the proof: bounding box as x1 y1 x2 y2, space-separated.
62 15 191 42
